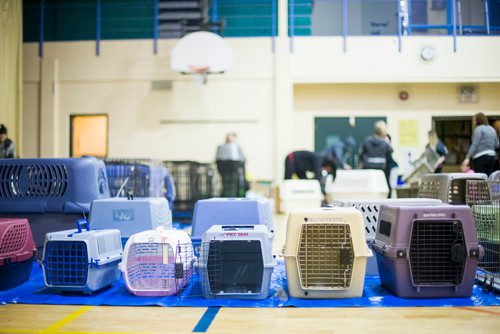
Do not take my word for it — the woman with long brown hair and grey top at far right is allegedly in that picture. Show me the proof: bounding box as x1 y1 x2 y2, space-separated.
461 113 499 175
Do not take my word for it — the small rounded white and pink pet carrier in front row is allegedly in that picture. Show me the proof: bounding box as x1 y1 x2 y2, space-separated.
120 227 196 296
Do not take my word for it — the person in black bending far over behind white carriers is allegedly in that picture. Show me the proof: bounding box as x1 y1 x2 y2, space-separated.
285 151 337 184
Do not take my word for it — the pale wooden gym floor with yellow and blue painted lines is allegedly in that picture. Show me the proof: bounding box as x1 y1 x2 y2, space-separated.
0 215 500 334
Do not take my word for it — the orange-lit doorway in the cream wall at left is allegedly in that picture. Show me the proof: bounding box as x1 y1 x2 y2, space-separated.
70 114 108 158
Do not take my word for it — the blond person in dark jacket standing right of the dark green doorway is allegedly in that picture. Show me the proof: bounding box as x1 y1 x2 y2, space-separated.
358 122 393 196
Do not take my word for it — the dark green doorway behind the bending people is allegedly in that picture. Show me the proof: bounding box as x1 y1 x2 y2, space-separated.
314 117 387 167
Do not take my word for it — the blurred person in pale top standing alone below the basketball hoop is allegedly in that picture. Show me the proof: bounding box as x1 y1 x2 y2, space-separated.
215 132 247 197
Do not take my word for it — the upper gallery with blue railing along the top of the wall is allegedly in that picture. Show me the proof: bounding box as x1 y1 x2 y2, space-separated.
23 0 500 57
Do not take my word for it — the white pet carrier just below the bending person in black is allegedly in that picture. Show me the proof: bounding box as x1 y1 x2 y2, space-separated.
279 180 323 213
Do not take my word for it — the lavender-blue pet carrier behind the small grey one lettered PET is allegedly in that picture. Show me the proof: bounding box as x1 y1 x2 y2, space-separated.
191 198 274 239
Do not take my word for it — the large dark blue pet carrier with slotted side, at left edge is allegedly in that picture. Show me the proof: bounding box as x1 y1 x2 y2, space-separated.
0 157 109 213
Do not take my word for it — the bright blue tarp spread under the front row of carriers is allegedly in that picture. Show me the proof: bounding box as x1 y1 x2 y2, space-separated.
0 260 500 307
